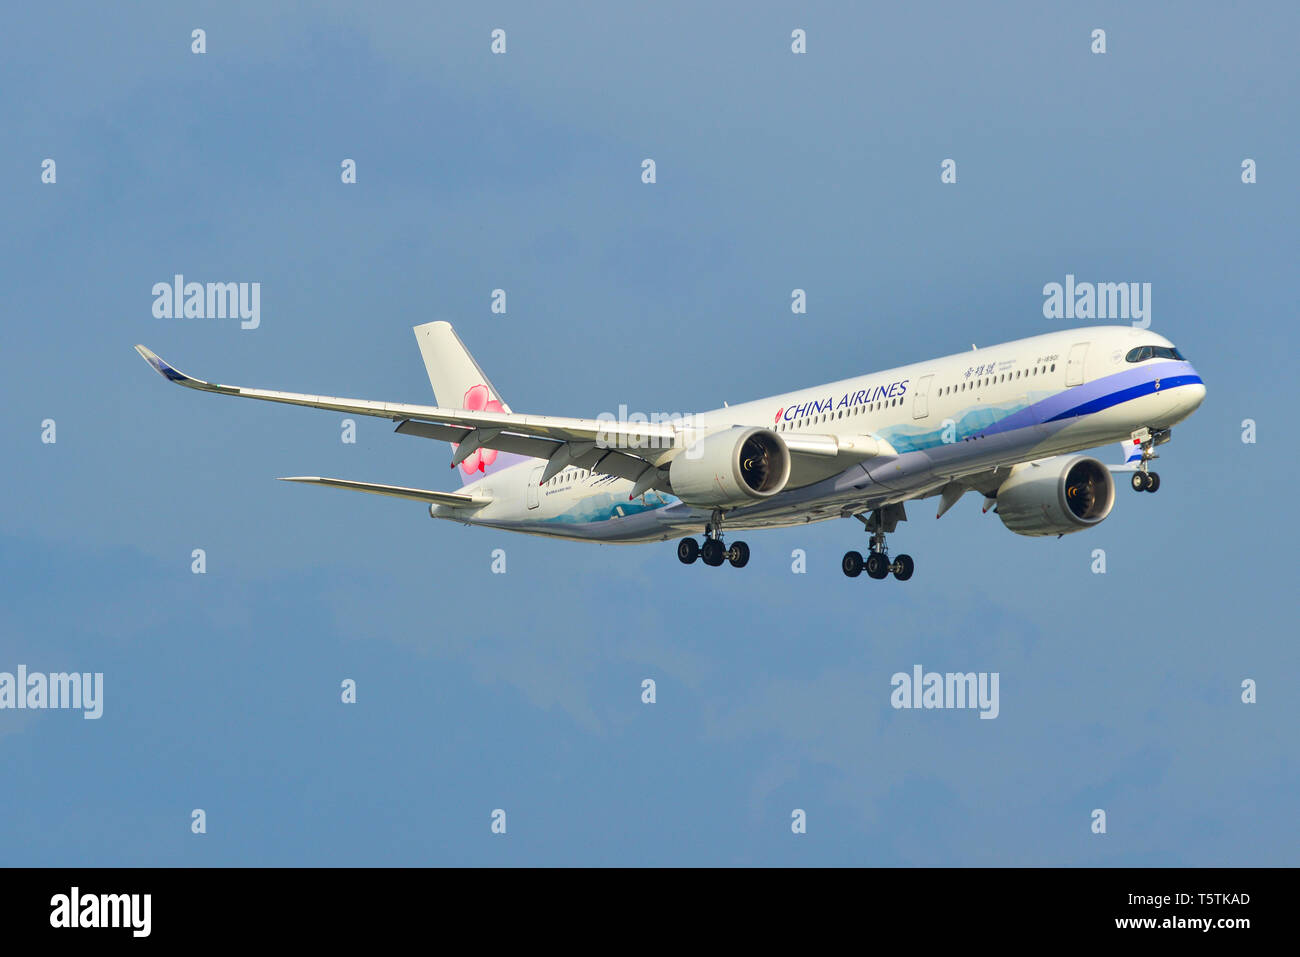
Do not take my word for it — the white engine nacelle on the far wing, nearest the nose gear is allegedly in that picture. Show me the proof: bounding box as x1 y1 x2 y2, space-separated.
997 455 1115 534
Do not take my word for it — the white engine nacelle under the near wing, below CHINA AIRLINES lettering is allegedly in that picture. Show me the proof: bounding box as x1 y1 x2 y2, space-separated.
668 426 790 508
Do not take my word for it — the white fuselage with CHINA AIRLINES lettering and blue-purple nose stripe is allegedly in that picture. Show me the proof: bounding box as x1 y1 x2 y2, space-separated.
432 326 1205 542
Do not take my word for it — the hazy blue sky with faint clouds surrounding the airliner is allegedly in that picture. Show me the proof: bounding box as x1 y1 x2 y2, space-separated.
0 3 1300 866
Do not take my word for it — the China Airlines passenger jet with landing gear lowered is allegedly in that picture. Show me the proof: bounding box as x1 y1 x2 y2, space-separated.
135 321 1205 581
